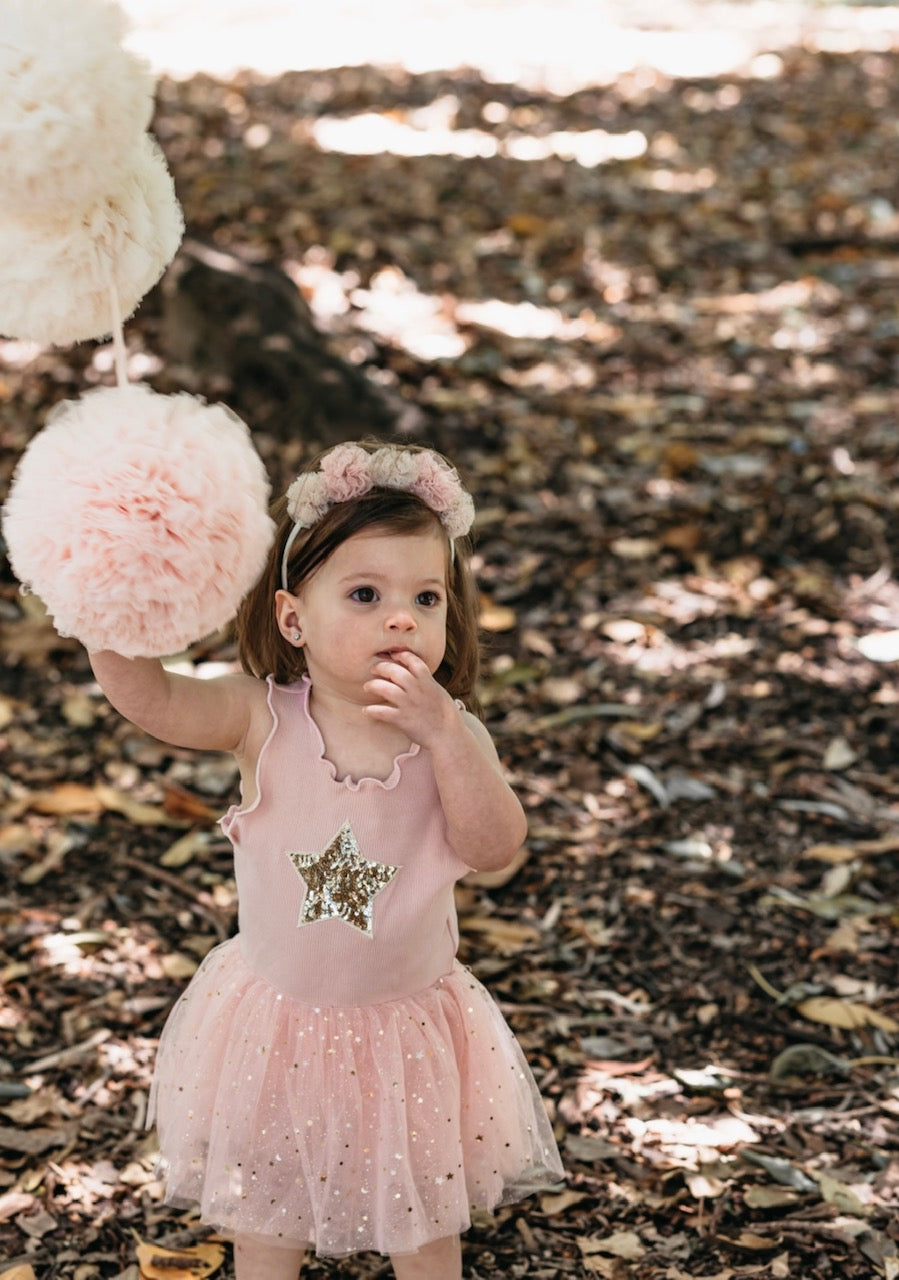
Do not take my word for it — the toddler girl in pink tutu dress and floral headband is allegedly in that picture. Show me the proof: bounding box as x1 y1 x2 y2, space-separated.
91 442 562 1280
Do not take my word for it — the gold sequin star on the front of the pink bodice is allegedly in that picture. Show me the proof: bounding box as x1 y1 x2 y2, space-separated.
287 822 400 937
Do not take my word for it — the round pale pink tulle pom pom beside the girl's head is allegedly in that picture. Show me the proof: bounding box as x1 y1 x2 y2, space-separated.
3 387 274 657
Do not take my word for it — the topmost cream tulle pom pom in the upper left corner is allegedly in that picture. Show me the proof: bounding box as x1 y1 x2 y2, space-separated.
0 0 154 215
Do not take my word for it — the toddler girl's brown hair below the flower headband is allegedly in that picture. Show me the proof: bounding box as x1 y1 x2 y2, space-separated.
236 440 480 714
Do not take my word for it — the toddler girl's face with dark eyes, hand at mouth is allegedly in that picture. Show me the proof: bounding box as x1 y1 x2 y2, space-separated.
278 530 447 701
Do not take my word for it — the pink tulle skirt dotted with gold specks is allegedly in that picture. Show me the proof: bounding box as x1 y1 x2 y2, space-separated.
150 938 563 1256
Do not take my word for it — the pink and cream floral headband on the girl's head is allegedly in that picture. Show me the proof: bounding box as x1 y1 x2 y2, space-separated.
280 444 474 590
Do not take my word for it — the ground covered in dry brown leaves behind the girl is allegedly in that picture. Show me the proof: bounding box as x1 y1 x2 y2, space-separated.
0 17 899 1280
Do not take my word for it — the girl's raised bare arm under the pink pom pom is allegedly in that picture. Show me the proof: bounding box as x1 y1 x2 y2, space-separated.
88 650 270 756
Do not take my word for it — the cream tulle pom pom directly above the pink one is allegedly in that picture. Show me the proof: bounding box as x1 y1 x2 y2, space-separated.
0 133 184 346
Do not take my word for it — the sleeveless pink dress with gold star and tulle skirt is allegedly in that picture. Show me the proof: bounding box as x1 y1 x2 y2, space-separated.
150 680 562 1256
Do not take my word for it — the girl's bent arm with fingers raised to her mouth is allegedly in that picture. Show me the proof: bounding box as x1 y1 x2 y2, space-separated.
366 654 528 872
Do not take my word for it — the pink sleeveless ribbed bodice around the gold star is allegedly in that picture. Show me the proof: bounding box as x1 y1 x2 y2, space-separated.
222 680 467 1005
